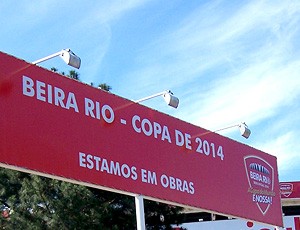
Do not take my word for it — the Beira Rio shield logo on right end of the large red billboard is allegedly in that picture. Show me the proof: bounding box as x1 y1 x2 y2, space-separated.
244 156 275 215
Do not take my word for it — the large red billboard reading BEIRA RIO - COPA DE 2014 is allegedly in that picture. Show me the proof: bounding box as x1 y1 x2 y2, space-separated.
0 53 282 226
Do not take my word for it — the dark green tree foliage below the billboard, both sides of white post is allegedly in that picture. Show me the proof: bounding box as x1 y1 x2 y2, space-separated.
0 168 181 230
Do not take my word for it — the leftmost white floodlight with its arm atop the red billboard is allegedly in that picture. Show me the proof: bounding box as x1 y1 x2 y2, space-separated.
32 49 81 69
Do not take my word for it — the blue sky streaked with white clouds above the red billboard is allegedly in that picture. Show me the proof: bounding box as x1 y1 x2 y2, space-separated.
0 0 300 181
